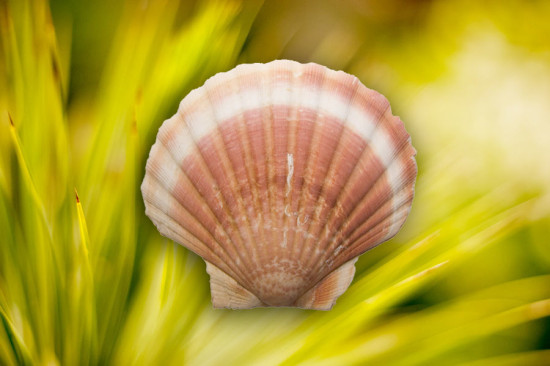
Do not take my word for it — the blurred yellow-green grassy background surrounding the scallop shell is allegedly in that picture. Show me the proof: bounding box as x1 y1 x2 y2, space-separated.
0 0 550 365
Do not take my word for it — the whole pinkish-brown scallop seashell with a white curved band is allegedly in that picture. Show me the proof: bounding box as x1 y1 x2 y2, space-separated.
141 60 417 310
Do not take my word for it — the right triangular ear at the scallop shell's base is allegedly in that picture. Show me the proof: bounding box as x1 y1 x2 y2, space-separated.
295 257 357 310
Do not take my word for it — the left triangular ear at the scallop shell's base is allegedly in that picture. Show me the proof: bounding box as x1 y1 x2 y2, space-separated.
205 261 265 309
